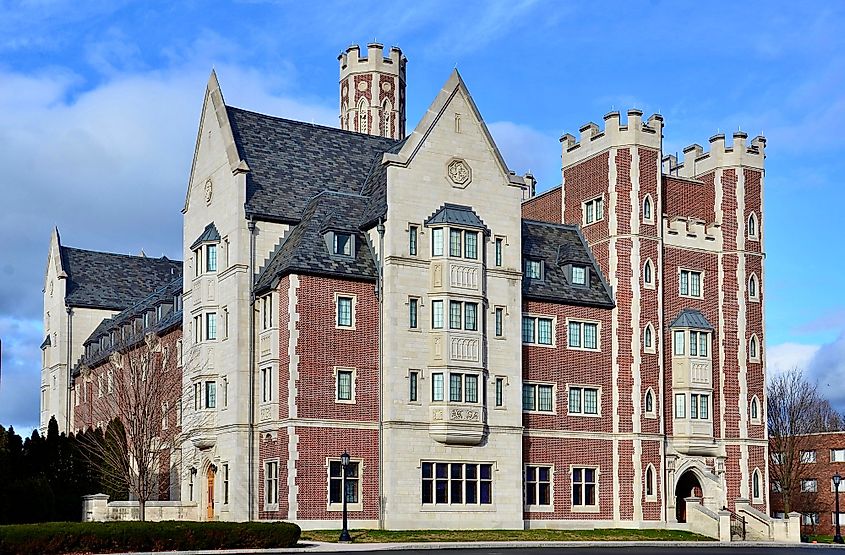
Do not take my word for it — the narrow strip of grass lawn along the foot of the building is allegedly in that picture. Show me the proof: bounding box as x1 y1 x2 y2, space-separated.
300 528 713 543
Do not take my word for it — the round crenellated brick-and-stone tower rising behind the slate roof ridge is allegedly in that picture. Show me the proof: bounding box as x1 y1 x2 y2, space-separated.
338 43 408 139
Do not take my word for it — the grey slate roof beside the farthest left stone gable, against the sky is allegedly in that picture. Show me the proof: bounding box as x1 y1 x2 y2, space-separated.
61 247 182 310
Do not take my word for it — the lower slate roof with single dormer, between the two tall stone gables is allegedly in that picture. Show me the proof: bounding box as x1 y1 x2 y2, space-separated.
256 191 378 294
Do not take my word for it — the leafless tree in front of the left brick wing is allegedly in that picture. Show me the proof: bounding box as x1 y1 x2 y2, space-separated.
78 333 182 520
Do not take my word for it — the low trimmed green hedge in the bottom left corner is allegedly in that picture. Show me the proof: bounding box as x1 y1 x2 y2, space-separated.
0 521 302 555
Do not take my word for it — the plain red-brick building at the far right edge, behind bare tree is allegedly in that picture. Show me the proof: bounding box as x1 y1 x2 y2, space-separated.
769 432 845 536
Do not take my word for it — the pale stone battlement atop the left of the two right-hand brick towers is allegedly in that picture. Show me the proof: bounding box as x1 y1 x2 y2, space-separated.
560 109 663 168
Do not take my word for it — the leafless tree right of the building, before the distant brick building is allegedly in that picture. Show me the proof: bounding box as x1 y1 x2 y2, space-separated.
766 368 842 513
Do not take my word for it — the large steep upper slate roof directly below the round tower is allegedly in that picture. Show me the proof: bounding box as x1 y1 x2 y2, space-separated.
226 106 397 223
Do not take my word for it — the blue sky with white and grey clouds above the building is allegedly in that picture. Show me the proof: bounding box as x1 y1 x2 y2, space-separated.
0 0 845 428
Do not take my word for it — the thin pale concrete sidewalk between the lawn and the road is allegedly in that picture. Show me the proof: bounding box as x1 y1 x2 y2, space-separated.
111 540 835 555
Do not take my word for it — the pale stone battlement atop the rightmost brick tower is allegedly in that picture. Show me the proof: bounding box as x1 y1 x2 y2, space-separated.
663 131 766 177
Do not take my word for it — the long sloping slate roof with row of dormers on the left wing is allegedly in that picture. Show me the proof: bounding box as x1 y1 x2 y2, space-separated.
74 274 182 375
